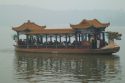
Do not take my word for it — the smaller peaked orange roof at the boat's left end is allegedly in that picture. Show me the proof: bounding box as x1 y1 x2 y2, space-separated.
12 20 46 32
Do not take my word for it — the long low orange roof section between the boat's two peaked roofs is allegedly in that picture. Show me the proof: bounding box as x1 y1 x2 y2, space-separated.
26 28 74 34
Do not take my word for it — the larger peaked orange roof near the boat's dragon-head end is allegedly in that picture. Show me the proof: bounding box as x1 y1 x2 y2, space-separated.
70 19 110 29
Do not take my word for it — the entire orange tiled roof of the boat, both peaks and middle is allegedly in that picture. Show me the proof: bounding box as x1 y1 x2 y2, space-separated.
12 19 110 35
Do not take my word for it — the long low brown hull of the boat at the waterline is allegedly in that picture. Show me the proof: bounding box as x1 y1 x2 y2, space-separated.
15 47 120 54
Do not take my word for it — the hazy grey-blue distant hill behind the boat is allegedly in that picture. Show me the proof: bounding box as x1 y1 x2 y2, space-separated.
0 5 125 27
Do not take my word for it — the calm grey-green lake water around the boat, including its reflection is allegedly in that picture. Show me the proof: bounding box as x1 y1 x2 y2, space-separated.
0 27 125 83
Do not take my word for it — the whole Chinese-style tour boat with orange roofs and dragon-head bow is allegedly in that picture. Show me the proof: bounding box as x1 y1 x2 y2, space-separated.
12 19 121 54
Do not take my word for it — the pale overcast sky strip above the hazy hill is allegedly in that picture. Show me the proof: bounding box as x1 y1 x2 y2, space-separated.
0 0 125 10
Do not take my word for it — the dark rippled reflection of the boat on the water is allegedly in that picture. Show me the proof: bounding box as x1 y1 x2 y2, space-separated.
15 52 120 83
